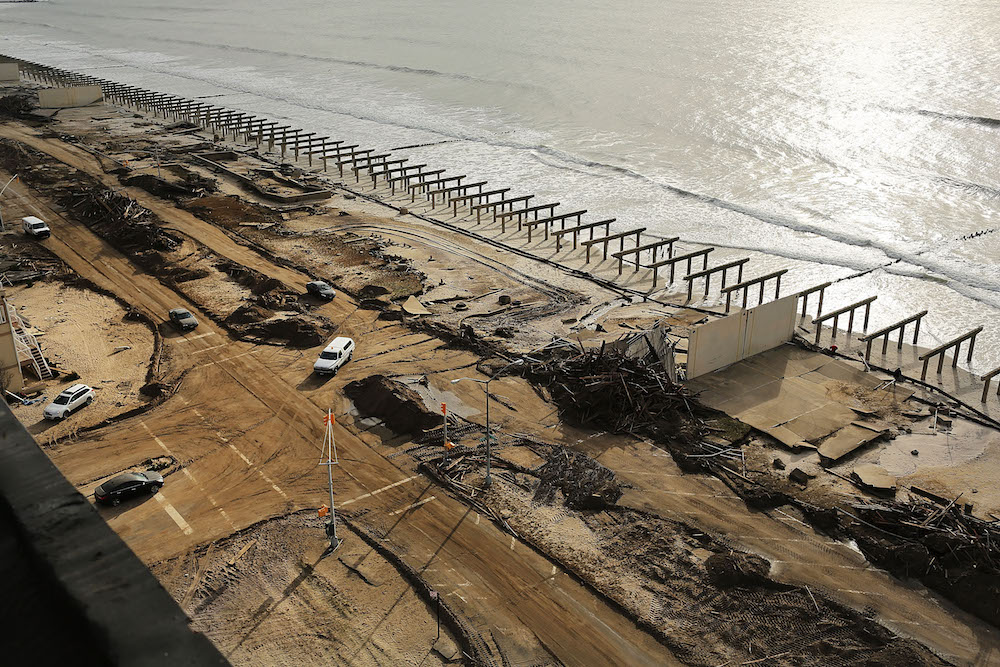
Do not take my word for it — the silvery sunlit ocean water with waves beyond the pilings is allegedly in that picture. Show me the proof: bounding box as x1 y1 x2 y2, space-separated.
0 0 1000 371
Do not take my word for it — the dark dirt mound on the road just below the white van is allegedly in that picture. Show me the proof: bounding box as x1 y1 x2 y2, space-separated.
344 375 441 434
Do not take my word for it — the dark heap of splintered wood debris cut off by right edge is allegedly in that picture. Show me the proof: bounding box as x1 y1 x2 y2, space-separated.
841 497 1000 626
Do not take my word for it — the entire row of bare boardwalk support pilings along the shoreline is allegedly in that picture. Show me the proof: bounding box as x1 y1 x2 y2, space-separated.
6 52 1000 402
